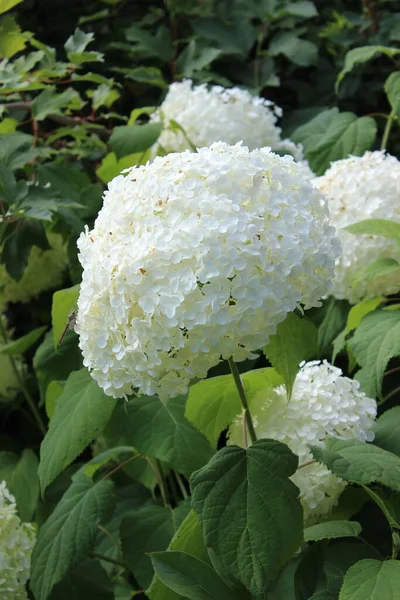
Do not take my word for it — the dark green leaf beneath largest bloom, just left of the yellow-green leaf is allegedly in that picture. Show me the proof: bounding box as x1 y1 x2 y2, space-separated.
107 396 212 475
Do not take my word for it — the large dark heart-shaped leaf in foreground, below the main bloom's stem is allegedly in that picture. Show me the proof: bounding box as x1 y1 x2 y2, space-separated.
190 440 303 594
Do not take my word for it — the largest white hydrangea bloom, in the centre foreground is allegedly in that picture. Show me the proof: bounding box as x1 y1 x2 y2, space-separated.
75 142 339 398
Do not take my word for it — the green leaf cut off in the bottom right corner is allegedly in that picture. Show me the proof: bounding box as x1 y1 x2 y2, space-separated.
339 559 400 600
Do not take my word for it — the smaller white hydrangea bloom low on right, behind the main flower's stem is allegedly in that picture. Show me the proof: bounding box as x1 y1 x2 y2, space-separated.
230 361 377 525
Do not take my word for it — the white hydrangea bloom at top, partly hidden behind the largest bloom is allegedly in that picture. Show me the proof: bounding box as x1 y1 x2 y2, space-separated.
151 79 303 160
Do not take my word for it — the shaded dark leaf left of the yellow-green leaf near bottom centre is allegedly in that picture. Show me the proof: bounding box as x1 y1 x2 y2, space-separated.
121 506 190 589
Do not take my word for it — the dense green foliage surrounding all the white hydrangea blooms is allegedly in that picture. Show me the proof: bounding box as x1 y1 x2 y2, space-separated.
0 0 400 600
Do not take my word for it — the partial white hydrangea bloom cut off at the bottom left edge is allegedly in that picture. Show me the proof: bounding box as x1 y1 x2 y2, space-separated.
0 481 36 600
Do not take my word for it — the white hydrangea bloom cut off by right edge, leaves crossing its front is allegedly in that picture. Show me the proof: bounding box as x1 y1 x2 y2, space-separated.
316 151 400 304
